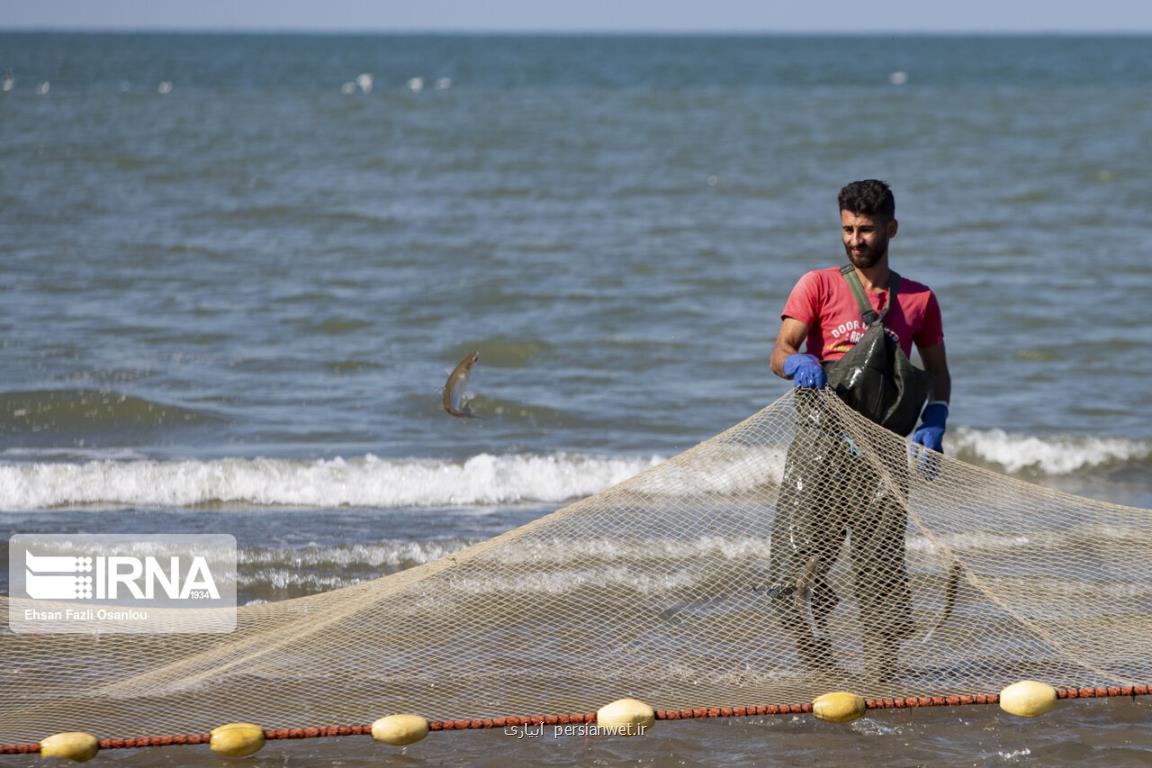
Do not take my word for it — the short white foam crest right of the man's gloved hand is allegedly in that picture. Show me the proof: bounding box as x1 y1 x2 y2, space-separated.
946 427 1152 474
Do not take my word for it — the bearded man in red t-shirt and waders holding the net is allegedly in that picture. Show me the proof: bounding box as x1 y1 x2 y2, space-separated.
768 180 952 680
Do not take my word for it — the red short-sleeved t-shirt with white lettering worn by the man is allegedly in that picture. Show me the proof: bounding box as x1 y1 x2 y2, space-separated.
780 267 943 362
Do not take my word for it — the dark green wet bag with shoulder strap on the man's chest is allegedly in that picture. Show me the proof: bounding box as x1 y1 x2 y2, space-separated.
825 265 932 435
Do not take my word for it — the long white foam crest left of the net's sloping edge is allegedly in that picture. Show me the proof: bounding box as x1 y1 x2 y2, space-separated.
0 454 661 510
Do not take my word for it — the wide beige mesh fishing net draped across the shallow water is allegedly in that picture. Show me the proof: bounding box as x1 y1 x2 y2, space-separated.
0 390 1152 743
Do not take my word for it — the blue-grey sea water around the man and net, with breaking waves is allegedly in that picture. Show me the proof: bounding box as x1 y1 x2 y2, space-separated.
0 33 1152 766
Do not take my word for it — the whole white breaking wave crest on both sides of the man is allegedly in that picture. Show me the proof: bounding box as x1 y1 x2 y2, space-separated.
0 427 1138 510
